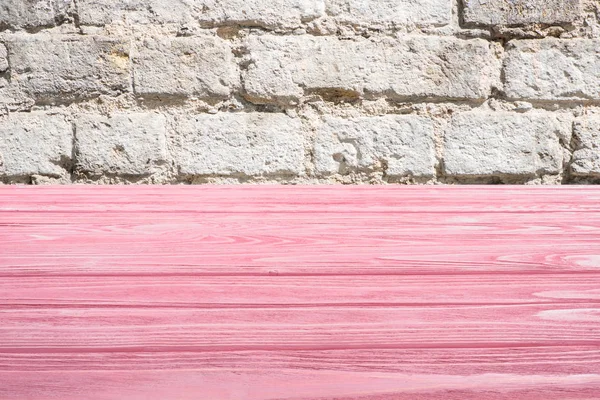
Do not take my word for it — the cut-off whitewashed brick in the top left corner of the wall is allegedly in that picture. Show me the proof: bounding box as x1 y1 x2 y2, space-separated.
0 0 73 30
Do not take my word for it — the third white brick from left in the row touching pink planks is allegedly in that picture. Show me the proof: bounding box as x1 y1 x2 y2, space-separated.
173 113 304 175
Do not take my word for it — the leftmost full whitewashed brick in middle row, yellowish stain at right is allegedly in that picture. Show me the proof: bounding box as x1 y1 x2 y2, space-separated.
6 35 130 102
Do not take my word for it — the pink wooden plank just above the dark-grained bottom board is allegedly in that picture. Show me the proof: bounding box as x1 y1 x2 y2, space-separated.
0 303 600 352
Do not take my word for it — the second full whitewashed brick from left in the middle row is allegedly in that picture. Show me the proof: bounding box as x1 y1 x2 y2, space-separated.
132 37 240 99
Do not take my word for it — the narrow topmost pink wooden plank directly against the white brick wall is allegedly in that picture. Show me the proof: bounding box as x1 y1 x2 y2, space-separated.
0 186 600 214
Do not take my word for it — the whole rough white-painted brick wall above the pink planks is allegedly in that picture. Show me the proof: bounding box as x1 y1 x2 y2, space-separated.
0 0 600 184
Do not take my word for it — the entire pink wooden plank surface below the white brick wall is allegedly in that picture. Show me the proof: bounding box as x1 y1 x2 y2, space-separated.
0 186 600 400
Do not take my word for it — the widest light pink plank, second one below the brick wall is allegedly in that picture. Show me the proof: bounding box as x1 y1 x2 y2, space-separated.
0 208 600 276
